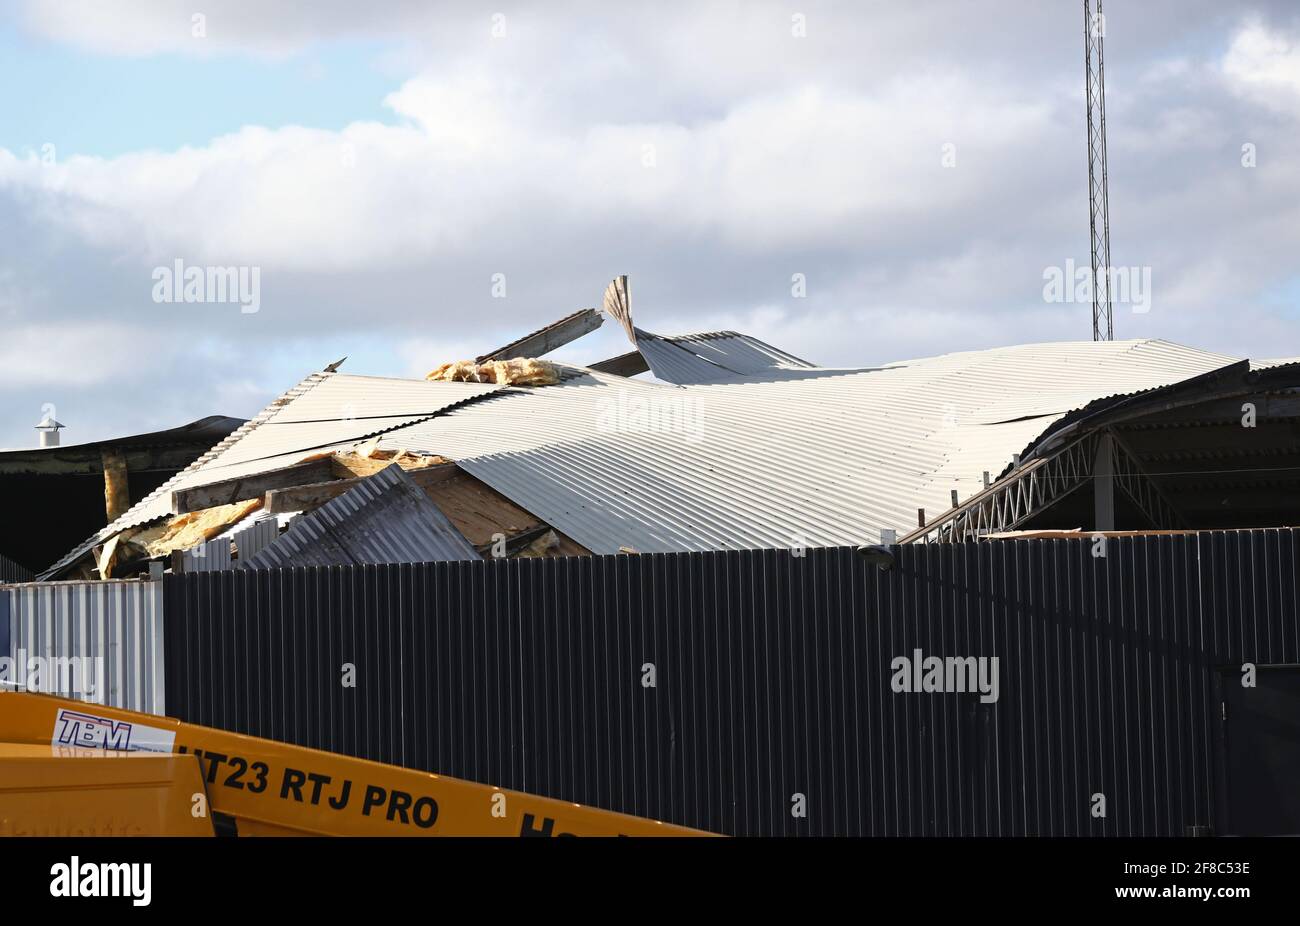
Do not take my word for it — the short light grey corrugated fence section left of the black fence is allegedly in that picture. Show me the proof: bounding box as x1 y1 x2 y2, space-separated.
0 581 166 714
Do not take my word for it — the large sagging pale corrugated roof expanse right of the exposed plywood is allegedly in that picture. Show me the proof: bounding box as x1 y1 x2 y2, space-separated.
381 341 1232 553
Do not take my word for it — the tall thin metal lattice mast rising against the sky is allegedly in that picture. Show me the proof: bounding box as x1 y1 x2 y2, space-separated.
1083 0 1115 341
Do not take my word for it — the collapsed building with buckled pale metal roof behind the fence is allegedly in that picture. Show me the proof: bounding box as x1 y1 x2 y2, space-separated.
22 277 1300 579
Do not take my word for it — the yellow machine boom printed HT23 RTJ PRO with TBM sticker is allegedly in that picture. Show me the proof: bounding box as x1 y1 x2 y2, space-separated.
0 692 709 836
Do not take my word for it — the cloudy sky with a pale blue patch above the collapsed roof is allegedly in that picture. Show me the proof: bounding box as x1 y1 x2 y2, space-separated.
0 0 1300 447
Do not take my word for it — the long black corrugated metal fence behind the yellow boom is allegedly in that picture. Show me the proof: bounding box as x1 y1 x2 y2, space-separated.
166 531 1300 835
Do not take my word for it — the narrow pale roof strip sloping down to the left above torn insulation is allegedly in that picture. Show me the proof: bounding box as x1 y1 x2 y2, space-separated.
40 373 503 579
